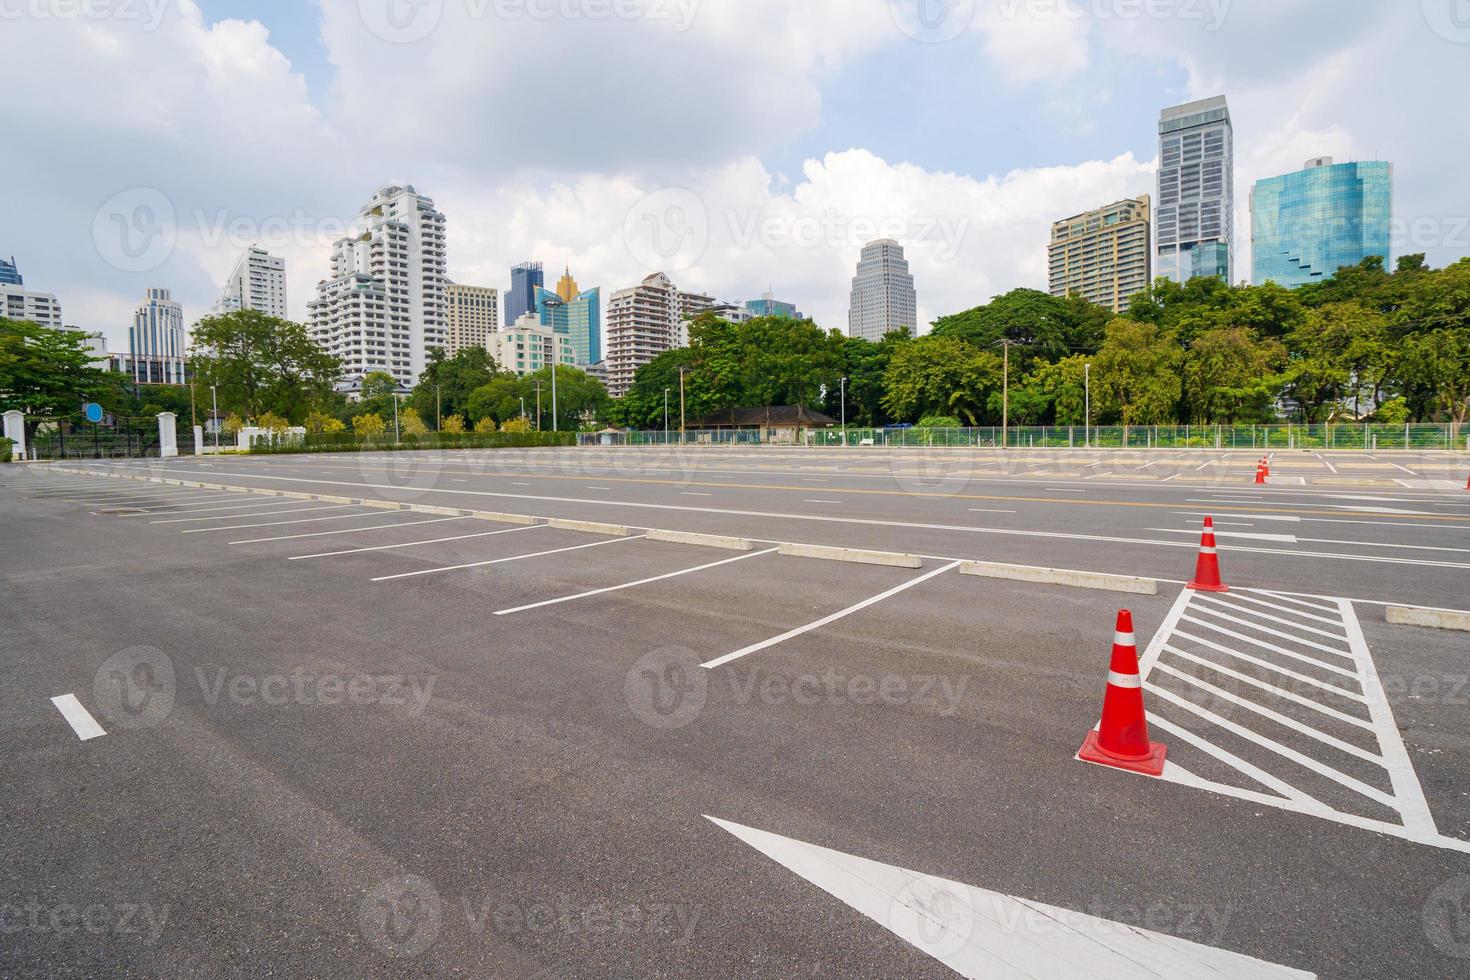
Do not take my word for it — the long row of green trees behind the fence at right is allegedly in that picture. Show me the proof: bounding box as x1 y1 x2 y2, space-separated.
612 256 1470 428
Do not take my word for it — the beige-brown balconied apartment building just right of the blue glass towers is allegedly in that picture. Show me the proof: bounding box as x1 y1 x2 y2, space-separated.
607 272 714 398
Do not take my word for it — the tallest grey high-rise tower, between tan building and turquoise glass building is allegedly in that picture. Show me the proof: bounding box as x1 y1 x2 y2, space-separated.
1154 96 1235 282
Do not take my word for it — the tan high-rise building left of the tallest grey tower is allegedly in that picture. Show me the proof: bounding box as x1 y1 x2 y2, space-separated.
1047 194 1152 313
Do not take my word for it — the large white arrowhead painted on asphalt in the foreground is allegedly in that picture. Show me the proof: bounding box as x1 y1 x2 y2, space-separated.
706 817 1316 980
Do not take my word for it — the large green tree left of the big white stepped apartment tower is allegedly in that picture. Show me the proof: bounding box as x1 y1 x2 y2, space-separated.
191 310 341 419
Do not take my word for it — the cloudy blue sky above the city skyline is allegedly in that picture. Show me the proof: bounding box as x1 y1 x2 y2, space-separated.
0 0 1470 352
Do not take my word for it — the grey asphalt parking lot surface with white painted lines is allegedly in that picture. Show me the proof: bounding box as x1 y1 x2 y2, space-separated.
0 450 1470 977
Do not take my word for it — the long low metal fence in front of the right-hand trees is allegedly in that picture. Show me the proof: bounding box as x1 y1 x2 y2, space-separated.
578 425 1470 453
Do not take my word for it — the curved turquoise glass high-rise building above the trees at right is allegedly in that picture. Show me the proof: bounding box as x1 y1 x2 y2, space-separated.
1251 157 1394 288
